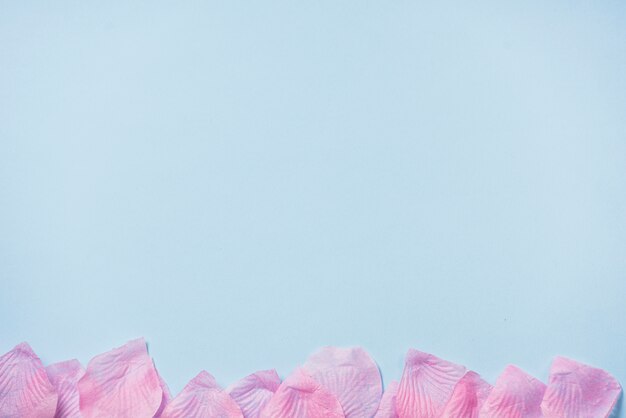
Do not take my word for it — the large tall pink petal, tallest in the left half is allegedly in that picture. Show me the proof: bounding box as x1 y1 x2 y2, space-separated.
78 338 163 418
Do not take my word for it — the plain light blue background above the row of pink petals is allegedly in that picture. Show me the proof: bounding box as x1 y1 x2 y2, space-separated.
0 1 626 416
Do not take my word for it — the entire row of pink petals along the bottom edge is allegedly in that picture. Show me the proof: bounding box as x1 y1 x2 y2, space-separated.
0 338 622 418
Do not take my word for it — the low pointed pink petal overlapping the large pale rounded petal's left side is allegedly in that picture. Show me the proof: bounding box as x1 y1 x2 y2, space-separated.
261 369 344 418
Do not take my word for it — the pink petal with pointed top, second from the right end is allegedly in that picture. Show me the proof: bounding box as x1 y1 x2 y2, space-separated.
480 366 546 418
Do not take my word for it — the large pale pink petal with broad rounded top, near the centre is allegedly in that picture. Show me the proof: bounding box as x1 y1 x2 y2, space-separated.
302 347 383 418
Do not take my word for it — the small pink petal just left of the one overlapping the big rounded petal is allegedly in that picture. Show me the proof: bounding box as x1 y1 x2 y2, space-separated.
226 370 280 418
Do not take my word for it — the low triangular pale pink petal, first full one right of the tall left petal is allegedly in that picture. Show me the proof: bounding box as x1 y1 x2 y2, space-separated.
161 371 243 418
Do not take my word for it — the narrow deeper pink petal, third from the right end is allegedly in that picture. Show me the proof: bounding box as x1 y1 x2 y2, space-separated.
441 371 492 418
